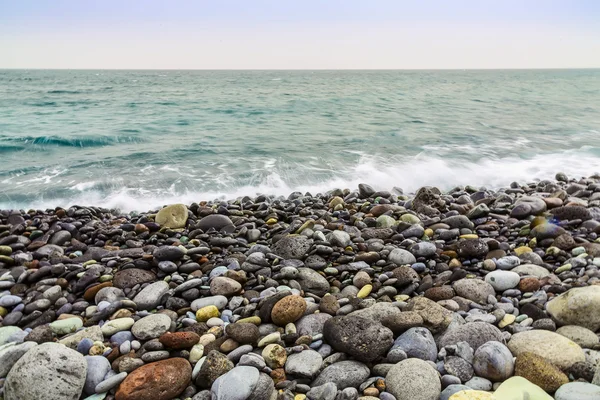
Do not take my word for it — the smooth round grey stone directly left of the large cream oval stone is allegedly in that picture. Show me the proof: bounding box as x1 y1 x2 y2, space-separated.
473 341 514 382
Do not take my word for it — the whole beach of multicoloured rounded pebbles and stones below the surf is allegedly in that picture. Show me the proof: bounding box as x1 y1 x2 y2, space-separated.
0 174 600 400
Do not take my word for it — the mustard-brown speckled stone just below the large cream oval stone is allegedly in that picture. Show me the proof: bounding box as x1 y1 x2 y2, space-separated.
515 352 569 393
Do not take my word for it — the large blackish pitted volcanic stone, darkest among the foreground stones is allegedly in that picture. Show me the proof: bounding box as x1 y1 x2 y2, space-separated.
323 316 394 362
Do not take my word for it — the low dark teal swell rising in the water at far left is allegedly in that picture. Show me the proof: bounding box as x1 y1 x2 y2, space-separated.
0 135 144 148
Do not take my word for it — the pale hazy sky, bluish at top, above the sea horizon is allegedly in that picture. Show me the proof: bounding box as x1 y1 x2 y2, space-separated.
0 0 600 69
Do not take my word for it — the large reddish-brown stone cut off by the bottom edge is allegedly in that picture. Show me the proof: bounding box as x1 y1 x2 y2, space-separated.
115 358 192 400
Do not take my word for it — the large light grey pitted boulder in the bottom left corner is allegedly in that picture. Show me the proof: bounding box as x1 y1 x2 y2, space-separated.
4 343 87 400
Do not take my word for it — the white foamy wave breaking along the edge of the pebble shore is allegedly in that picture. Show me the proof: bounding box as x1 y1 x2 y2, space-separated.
0 146 600 212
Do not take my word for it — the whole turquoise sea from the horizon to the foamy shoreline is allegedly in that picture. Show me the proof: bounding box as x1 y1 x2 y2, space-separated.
0 70 600 211
